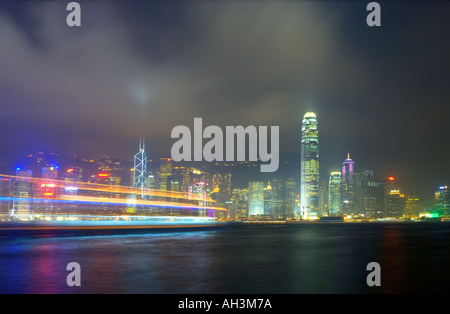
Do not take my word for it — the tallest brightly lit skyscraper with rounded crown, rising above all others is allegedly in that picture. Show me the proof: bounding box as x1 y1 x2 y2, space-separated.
300 112 319 219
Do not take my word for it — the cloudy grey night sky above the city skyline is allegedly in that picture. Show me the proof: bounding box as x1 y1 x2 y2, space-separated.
0 1 450 196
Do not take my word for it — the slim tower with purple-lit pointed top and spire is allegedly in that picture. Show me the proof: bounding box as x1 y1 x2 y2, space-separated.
341 154 355 215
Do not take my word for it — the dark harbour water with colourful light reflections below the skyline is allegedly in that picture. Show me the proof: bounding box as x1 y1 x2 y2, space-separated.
0 223 450 294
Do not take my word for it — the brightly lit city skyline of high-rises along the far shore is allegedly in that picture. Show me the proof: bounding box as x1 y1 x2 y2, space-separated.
3 121 447 220
